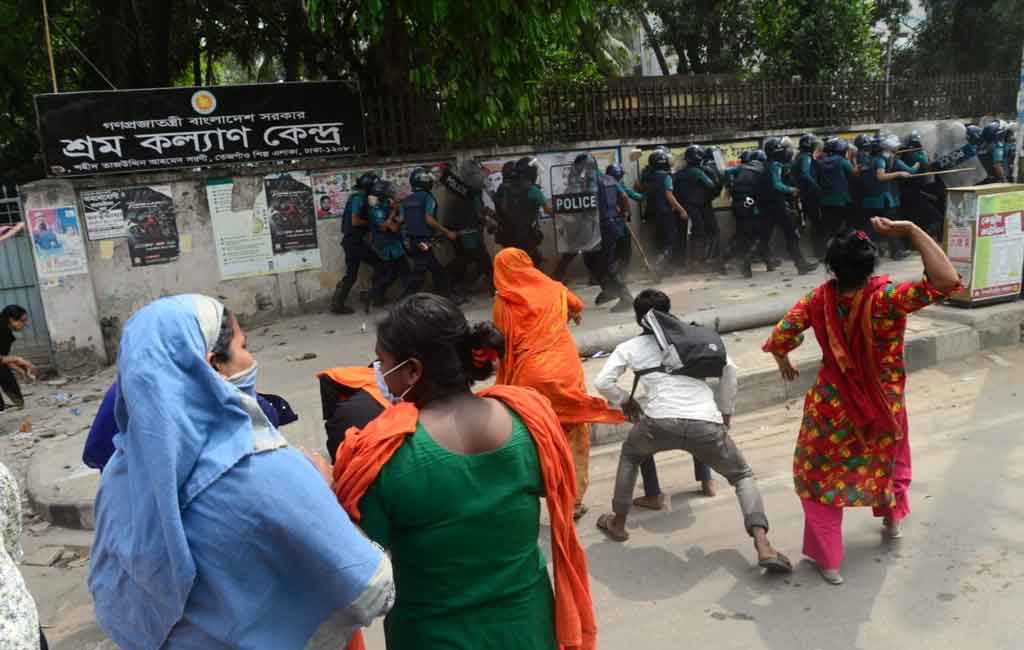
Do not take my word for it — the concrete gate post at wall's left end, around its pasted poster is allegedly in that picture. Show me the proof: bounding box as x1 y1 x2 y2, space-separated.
18 180 109 374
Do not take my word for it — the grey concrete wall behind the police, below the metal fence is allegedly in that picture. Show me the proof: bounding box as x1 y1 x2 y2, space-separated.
20 114 1007 367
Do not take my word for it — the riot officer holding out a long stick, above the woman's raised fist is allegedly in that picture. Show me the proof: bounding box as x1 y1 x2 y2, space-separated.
860 134 918 260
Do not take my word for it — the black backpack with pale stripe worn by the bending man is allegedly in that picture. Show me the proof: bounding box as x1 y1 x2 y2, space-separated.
630 309 727 399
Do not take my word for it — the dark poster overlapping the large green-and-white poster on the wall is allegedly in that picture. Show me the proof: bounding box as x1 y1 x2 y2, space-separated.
263 172 317 255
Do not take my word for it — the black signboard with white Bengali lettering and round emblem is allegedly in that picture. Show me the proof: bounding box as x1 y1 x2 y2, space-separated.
36 81 367 176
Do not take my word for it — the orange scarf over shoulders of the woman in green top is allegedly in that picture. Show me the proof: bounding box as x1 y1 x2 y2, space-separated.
334 386 597 650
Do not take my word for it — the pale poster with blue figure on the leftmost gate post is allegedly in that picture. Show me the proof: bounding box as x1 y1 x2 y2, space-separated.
28 207 89 280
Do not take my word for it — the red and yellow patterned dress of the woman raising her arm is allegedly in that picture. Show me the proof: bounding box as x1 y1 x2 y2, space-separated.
763 277 943 515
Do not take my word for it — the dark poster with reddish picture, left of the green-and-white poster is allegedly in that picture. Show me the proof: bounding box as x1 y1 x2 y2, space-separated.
122 185 180 266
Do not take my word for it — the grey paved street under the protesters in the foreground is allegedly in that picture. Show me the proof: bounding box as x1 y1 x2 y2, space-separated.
14 346 1024 650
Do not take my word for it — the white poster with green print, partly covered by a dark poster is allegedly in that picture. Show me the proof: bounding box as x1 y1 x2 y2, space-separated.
206 178 321 279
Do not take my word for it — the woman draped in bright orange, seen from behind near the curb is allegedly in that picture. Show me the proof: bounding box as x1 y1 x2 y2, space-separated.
494 248 625 519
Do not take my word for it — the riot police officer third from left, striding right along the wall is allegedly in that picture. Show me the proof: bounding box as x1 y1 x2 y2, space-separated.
398 167 465 303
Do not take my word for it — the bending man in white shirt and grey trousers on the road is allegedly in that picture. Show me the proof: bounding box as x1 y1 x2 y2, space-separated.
594 289 793 572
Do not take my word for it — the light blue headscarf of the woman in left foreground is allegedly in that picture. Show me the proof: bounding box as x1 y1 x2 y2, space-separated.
89 295 287 648
